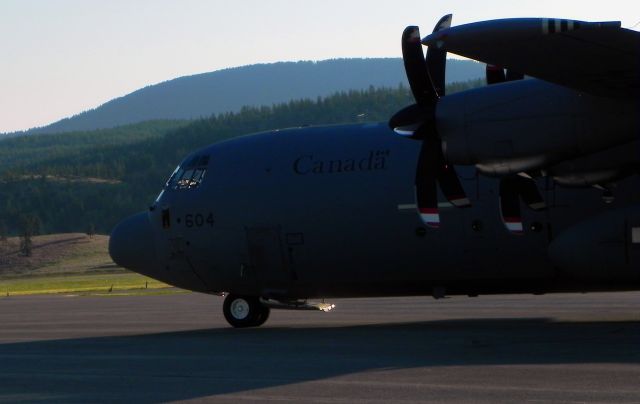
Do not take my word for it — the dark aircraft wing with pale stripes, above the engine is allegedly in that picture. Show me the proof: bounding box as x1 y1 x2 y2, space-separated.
422 18 640 98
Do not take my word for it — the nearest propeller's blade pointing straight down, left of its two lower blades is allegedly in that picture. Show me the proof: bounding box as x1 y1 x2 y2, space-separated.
415 126 440 229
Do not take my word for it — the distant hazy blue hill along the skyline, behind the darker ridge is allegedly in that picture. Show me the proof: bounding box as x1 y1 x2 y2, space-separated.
28 58 484 133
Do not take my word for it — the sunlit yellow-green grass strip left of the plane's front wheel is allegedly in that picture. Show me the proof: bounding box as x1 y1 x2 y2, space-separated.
0 272 170 297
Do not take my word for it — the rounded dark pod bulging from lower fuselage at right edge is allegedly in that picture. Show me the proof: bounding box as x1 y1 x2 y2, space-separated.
549 205 640 280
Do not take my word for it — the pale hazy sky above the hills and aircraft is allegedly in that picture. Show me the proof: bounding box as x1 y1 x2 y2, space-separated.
0 0 640 132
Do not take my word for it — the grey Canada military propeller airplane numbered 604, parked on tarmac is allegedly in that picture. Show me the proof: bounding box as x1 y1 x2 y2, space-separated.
109 15 640 327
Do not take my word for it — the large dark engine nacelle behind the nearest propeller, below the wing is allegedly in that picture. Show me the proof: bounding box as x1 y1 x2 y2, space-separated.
436 80 640 175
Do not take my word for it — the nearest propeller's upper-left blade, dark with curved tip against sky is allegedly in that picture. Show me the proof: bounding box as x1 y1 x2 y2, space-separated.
402 26 437 106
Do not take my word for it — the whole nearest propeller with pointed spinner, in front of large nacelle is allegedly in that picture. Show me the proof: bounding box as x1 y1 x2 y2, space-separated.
389 14 471 228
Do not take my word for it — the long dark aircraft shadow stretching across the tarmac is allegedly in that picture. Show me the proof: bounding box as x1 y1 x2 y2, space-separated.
0 318 640 402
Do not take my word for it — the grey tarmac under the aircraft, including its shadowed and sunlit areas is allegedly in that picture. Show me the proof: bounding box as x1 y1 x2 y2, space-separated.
0 293 640 403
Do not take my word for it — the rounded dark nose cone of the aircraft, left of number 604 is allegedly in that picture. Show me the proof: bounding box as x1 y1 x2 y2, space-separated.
109 212 157 277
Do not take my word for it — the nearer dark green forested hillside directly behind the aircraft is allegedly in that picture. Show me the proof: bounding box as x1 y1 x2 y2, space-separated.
0 80 483 237
